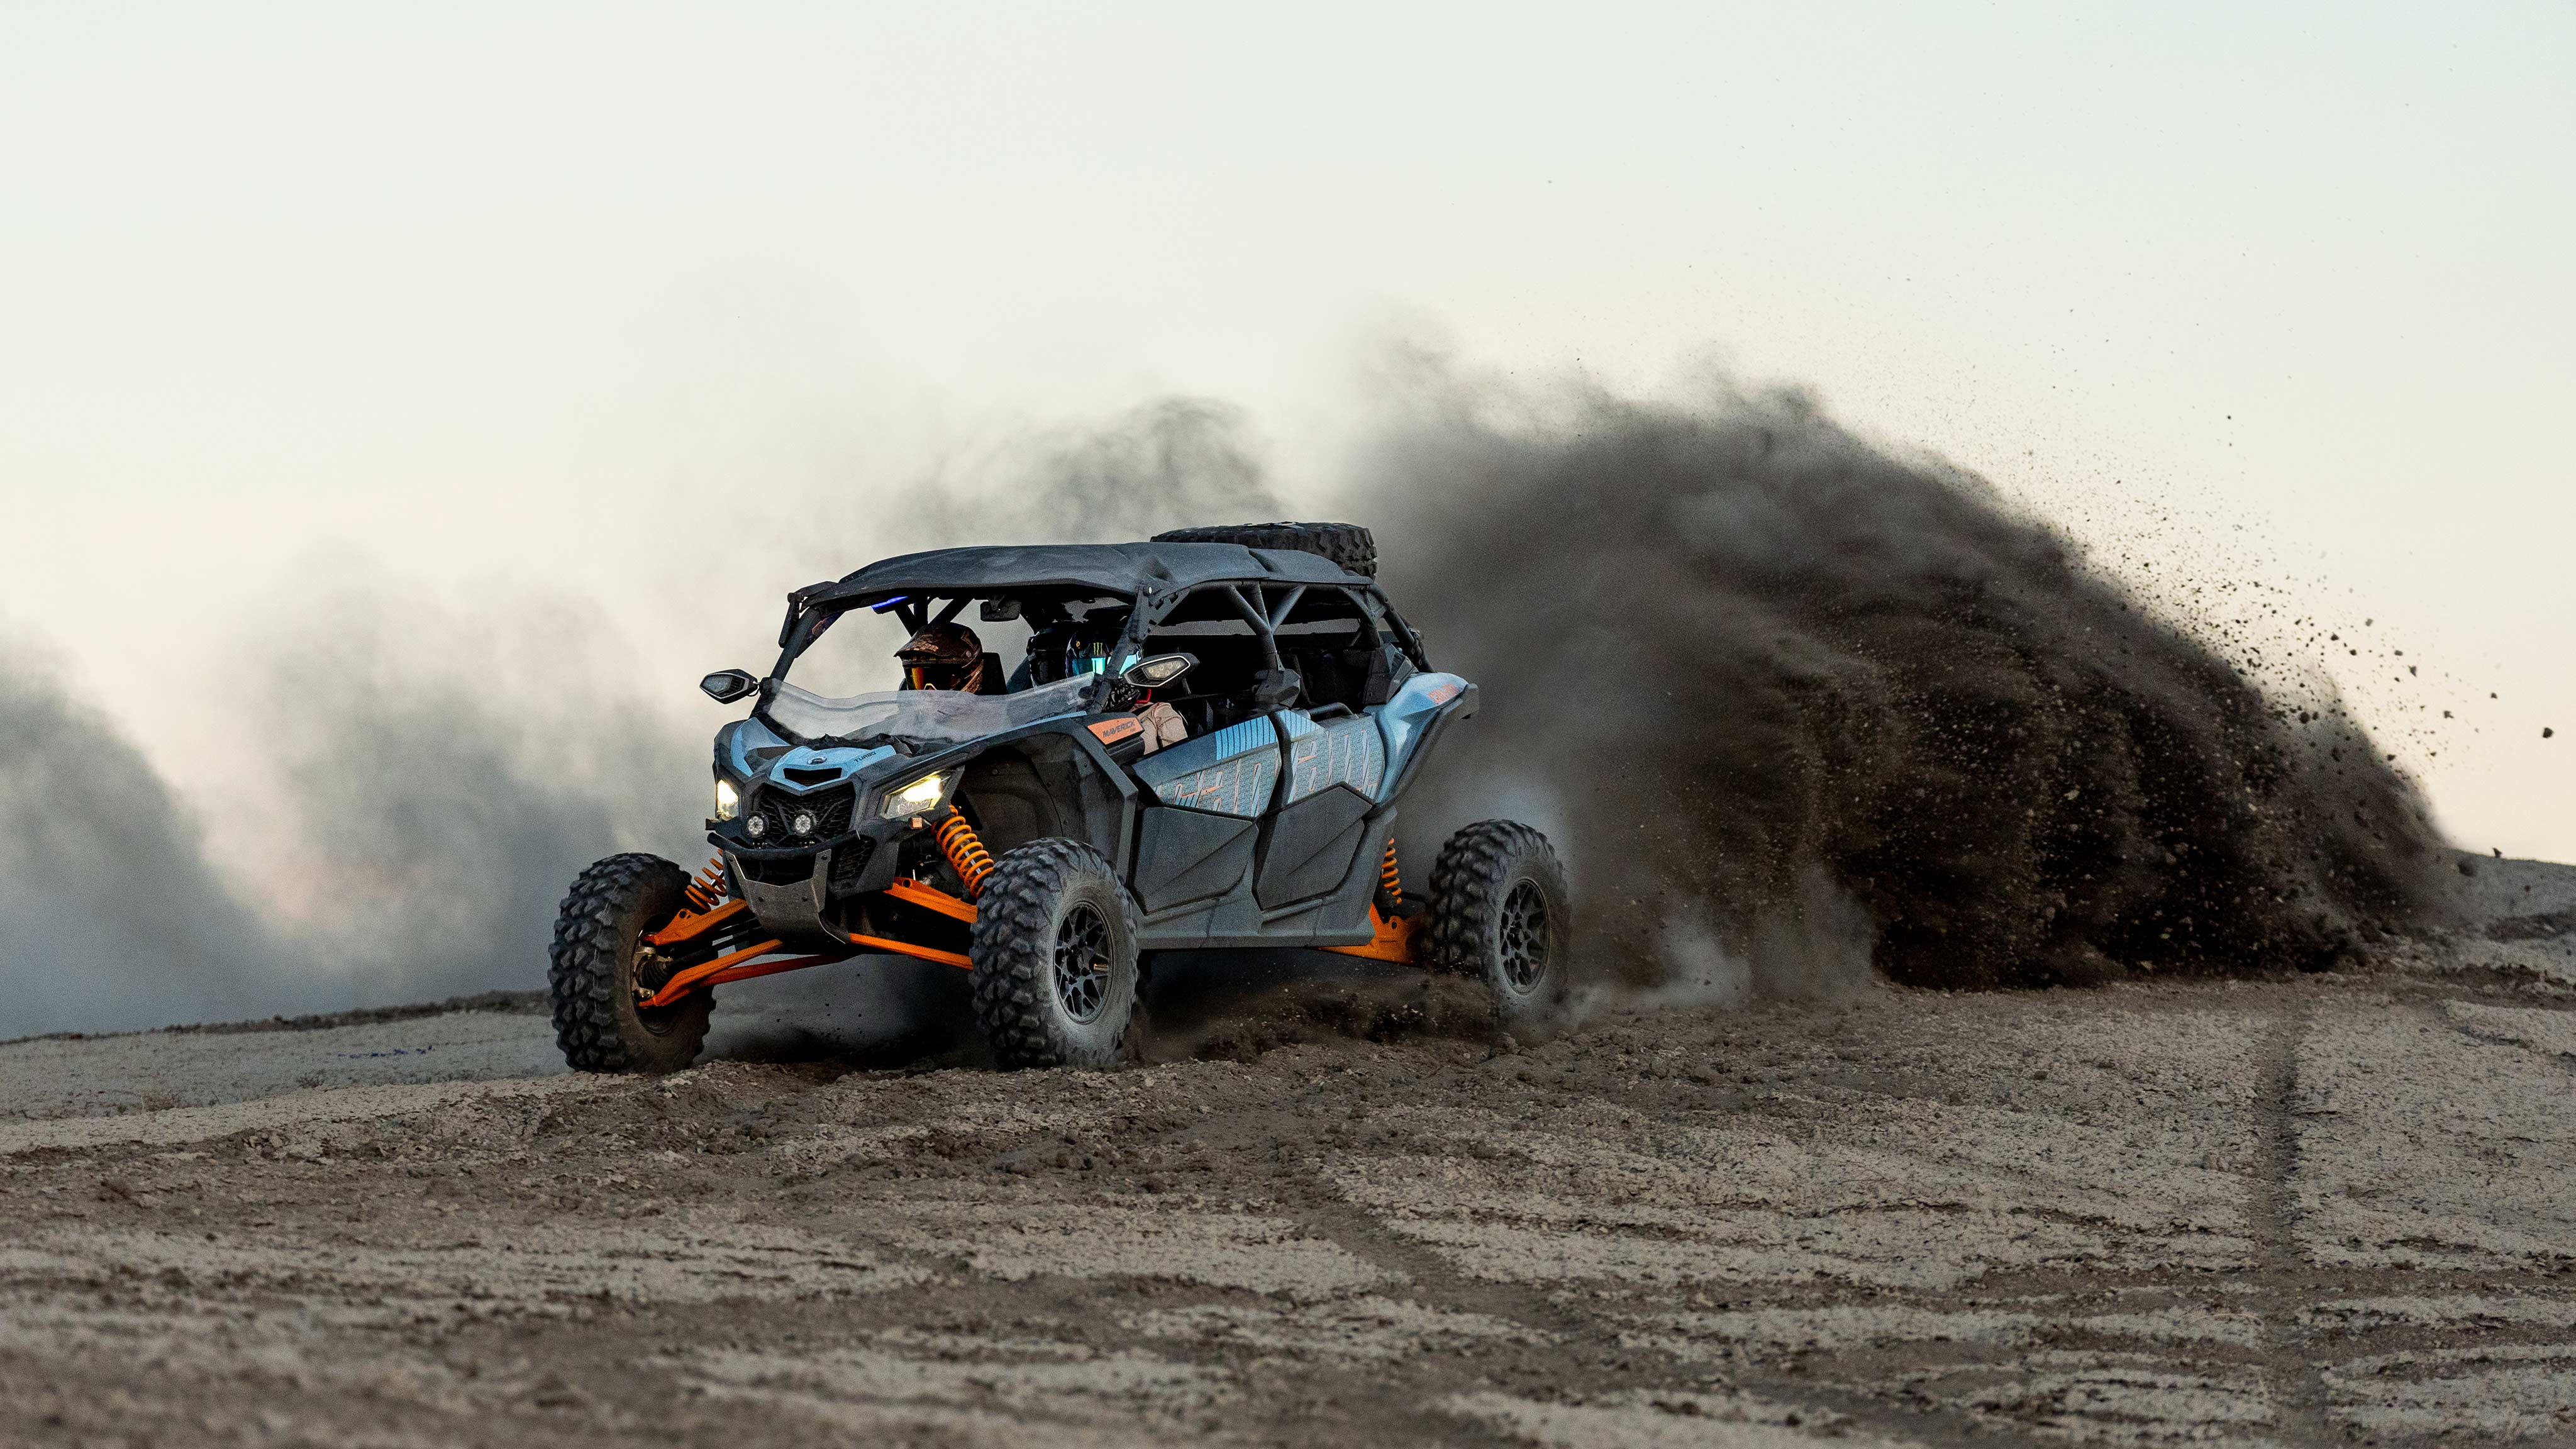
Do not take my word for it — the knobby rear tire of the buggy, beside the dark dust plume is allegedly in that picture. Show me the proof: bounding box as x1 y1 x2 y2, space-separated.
1432 820 1574 1031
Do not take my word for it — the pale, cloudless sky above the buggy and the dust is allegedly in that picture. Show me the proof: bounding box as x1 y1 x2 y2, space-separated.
15 0 2576 858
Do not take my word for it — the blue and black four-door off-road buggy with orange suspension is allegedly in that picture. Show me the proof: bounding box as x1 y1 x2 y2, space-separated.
548 523 1572 1072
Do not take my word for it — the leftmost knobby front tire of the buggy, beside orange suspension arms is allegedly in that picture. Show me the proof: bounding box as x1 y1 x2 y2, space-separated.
546 856 716 1072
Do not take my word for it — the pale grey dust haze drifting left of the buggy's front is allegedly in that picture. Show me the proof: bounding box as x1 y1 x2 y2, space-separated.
0 596 706 1039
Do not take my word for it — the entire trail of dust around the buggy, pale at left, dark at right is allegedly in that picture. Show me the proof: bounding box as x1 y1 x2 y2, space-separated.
0 379 2437 1036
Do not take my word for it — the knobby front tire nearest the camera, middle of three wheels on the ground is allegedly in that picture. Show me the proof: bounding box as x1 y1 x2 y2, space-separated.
969 840 1136 1067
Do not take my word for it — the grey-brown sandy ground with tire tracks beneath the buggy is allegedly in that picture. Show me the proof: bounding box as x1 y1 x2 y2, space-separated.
0 863 2576 1449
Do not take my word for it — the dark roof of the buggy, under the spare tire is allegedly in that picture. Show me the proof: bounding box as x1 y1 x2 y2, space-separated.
794 544 1370 609
